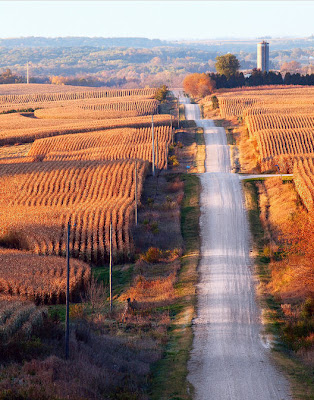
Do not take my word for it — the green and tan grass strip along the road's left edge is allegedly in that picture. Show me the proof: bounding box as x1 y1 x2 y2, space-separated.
151 174 200 400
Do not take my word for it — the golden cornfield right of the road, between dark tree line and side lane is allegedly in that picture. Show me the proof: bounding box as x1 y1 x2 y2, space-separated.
217 86 314 172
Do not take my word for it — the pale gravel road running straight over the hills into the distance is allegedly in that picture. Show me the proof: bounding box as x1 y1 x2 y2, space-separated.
185 99 291 400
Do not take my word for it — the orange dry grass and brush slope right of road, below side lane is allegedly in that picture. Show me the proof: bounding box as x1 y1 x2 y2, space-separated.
259 178 314 301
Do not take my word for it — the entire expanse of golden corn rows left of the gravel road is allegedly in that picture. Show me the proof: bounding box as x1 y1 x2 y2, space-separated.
0 85 172 304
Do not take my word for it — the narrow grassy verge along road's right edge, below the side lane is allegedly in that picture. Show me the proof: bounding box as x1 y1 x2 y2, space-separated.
243 181 314 400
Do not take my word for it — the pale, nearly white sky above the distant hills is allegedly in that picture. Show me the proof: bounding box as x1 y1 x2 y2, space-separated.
0 0 314 40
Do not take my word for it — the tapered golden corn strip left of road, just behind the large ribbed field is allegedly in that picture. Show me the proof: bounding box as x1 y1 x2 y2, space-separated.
28 126 171 169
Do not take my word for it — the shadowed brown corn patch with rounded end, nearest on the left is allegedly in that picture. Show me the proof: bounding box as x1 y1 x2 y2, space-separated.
0 249 91 304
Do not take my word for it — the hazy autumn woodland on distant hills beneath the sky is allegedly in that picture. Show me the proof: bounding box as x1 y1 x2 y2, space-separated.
0 37 314 87
